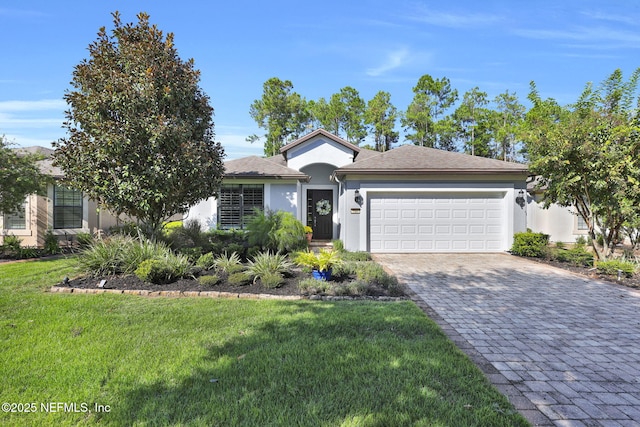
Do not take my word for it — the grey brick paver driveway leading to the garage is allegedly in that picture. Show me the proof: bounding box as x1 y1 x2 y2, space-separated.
375 254 640 426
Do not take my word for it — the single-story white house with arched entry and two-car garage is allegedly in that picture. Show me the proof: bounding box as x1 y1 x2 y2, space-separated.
188 129 528 252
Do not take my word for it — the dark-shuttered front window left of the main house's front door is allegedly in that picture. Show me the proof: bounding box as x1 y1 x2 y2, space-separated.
218 184 264 229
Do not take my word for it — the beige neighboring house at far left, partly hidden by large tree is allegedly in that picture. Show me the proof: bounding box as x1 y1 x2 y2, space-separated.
0 147 130 247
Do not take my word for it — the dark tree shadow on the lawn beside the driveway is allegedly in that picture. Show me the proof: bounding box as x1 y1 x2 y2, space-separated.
102 301 526 426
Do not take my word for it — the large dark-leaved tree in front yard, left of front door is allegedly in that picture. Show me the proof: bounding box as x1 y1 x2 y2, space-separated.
54 12 224 241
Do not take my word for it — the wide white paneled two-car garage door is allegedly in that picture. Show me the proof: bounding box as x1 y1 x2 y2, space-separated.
369 193 507 252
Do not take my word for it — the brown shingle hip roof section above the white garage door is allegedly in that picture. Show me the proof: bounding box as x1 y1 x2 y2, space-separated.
336 145 527 176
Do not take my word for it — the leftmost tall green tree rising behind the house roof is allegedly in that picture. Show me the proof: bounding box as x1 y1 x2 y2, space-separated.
247 77 311 156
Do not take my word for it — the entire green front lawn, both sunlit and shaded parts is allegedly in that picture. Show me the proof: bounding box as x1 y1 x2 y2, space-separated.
0 259 527 426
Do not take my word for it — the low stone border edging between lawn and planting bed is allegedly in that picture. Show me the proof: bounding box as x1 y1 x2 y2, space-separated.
49 286 409 302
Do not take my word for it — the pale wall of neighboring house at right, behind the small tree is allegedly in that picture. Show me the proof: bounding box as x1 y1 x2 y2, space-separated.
527 178 589 243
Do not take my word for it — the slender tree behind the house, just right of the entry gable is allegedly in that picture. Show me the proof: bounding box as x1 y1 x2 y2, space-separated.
364 91 399 151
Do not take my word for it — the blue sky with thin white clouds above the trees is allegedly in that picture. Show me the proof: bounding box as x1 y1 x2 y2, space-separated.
0 0 640 159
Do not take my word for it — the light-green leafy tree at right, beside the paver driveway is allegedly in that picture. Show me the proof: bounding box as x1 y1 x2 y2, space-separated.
524 70 640 259
